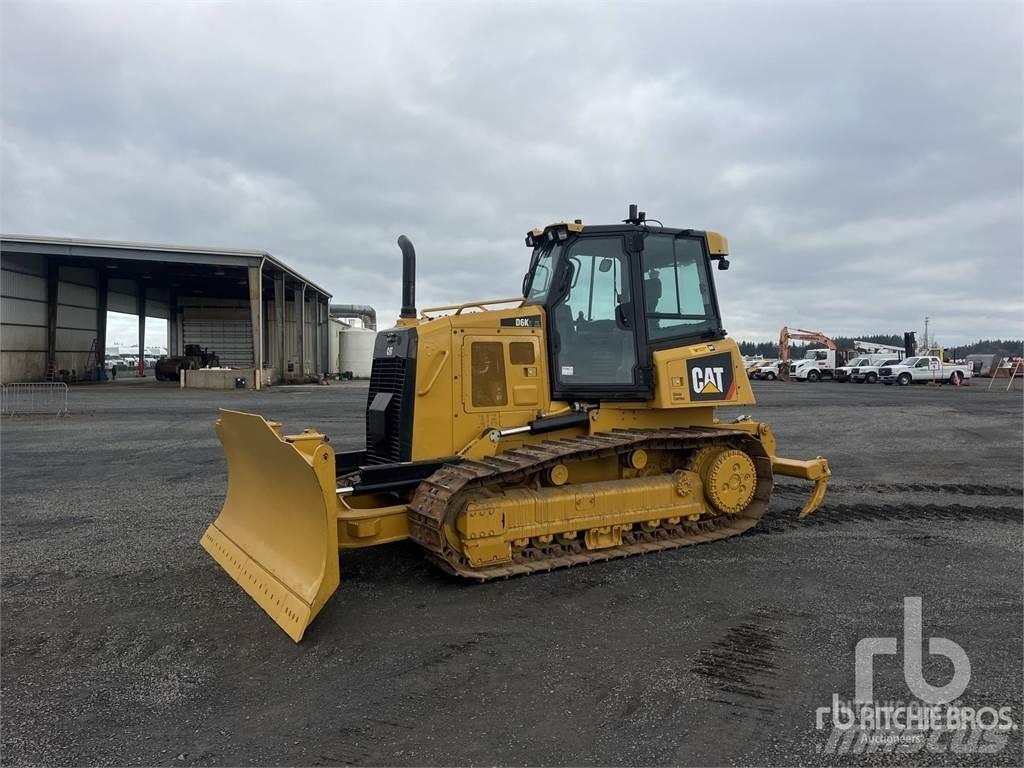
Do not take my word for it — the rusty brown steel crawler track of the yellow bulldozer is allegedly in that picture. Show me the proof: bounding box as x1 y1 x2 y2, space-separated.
409 429 772 582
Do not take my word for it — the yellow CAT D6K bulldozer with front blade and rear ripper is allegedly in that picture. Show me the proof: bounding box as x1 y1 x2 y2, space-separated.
202 205 831 642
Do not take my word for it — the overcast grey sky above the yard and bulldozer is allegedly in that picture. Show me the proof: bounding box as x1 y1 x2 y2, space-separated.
0 1 1024 343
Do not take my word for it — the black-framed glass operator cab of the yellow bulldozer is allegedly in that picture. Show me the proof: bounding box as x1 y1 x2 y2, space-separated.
523 207 728 400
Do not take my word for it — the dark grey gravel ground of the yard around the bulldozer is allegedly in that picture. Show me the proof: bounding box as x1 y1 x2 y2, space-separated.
0 380 1024 766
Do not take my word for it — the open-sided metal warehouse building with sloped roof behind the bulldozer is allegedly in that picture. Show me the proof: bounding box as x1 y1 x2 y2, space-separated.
0 236 332 388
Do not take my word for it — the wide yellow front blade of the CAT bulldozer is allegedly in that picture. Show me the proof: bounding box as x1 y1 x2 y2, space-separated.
202 411 339 642
